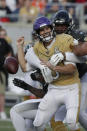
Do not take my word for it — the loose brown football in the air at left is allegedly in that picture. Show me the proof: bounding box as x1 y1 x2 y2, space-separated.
4 56 19 74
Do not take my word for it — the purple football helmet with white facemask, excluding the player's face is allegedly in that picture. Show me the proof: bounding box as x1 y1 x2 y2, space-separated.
33 16 54 42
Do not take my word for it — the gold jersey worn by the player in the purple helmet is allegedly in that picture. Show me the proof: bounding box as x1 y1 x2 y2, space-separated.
34 34 80 86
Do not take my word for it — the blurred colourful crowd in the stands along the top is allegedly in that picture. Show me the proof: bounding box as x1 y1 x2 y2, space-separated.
0 0 87 23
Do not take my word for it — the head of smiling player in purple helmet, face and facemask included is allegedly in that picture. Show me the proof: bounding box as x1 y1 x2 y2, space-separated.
33 16 55 43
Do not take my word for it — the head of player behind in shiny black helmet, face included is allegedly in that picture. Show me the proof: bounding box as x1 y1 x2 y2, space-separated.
52 10 72 34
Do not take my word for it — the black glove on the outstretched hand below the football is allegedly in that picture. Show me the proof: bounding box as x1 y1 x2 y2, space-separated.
13 78 29 90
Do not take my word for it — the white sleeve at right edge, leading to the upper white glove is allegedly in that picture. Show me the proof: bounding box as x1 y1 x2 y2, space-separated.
65 52 87 63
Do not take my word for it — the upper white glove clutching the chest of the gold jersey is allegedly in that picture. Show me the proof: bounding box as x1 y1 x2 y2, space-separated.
49 52 64 66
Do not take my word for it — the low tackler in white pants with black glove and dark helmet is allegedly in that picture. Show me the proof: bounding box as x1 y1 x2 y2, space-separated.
10 70 48 131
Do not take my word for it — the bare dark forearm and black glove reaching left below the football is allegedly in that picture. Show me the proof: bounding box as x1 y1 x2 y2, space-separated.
13 78 45 98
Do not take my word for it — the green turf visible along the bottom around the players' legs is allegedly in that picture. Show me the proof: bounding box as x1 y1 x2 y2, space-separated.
0 107 85 131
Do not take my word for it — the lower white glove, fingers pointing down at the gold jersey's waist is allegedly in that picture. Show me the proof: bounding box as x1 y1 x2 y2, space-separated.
40 65 53 83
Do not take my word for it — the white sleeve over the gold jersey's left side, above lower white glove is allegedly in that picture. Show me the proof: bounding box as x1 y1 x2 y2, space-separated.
25 47 41 68
